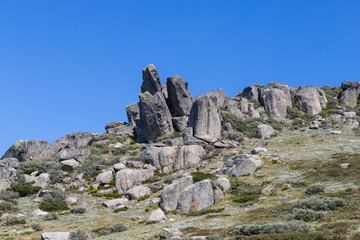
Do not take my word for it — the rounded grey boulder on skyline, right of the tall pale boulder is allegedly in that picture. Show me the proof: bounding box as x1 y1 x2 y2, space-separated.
294 86 327 115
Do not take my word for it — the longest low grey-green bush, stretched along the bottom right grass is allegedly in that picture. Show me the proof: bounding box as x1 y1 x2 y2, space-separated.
231 221 310 236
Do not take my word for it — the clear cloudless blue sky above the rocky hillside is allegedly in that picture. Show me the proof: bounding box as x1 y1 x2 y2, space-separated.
0 0 360 155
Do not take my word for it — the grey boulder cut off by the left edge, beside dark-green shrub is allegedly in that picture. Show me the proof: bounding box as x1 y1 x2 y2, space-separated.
0 158 19 191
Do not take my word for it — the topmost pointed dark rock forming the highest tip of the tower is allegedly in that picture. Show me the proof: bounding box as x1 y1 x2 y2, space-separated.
141 64 162 95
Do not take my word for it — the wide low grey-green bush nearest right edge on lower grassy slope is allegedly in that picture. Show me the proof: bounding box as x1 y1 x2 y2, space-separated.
291 196 345 211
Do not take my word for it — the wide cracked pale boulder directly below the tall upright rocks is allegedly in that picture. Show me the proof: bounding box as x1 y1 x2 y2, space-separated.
140 145 205 173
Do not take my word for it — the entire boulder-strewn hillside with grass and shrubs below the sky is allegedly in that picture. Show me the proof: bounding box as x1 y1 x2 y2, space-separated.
0 65 360 240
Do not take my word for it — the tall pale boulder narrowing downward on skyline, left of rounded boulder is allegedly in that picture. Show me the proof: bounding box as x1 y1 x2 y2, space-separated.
259 83 292 120
